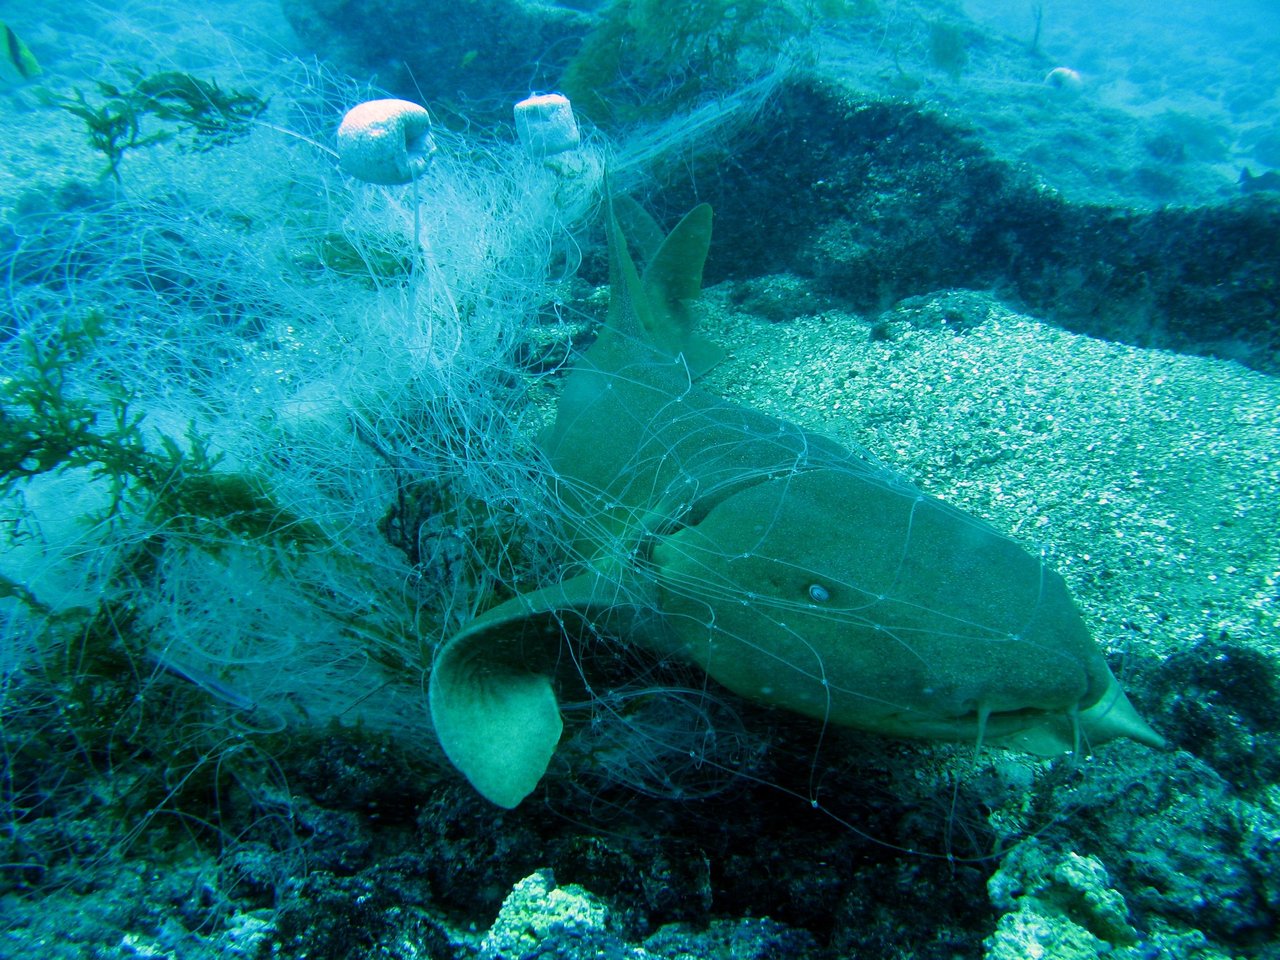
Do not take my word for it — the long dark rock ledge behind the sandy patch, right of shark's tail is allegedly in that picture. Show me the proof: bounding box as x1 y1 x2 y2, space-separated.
667 78 1280 372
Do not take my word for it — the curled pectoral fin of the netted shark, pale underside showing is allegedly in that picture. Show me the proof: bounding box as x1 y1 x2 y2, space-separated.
428 573 645 809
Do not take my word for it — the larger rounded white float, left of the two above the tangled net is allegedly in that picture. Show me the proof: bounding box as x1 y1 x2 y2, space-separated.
338 100 435 186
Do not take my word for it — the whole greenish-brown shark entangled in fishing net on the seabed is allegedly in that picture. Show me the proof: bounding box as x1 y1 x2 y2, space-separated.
430 206 1161 806
